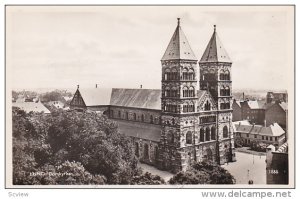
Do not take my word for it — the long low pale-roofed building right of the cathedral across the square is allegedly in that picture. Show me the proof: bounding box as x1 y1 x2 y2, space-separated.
233 122 286 147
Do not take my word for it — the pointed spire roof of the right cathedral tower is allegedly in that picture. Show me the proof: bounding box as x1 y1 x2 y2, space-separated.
200 25 232 63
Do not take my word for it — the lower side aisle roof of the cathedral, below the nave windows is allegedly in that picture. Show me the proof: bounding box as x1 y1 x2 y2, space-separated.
113 120 161 142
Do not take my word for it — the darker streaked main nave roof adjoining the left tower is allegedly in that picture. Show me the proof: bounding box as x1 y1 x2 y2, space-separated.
110 88 161 110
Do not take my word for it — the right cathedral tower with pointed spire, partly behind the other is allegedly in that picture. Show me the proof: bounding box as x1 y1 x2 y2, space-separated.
199 25 235 164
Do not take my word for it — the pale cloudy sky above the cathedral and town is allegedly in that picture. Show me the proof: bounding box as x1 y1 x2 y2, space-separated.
6 6 294 90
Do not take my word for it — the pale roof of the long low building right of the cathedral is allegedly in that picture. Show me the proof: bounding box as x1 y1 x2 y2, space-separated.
235 123 285 136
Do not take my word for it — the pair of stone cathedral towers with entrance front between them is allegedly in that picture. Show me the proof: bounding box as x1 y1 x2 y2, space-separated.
159 18 235 172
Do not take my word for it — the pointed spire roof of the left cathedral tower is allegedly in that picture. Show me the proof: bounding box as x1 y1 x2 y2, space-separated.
161 18 197 60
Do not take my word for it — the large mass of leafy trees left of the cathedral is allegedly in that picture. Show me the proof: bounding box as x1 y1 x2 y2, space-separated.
13 109 140 184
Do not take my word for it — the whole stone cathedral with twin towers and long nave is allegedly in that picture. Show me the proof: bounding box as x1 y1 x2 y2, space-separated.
70 18 235 173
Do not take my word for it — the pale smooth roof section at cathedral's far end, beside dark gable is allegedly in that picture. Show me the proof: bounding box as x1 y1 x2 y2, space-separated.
79 88 112 106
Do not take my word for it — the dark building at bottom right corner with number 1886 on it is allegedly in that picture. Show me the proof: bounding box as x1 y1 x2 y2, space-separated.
266 143 289 184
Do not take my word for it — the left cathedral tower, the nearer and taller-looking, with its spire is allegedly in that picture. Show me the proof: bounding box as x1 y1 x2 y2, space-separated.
160 18 198 172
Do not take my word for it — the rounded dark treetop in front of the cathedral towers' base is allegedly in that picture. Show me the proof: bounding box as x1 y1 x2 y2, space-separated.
169 162 235 184
